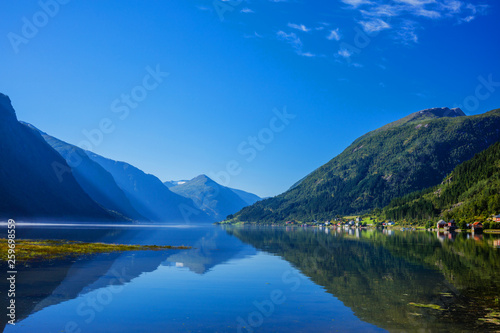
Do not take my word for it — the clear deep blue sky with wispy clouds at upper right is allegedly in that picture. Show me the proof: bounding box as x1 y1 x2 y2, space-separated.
0 0 500 196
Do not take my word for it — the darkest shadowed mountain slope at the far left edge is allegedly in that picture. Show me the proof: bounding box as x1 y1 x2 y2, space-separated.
0 94 119 220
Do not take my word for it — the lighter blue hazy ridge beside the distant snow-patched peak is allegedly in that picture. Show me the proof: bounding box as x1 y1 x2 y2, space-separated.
86 152 215 223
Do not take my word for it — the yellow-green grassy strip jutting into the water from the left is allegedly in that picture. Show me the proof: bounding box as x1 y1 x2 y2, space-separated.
0 239 191 262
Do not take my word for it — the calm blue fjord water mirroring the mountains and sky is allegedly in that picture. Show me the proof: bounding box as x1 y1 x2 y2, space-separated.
0 225 500 332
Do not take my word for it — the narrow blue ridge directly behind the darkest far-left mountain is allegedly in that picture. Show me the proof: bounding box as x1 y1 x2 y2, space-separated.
26 124 147 221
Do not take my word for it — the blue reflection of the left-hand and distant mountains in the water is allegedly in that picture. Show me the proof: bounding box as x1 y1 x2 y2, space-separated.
0 227 255 330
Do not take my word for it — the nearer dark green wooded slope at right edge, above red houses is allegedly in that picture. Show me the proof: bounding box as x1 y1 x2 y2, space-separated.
380 142 500 223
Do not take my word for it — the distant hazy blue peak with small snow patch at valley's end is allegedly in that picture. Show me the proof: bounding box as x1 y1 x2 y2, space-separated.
164 175 260 221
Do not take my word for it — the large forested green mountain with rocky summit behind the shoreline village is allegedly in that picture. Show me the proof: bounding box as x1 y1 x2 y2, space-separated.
229 108 500 222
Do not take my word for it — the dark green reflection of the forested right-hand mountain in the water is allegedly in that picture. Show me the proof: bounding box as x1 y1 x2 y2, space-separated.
226 227 500 331
